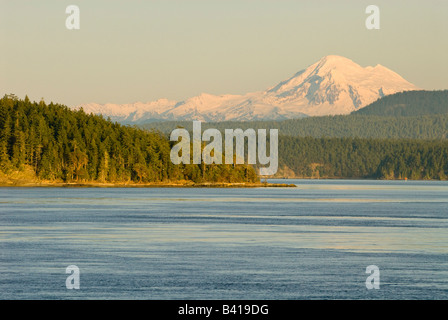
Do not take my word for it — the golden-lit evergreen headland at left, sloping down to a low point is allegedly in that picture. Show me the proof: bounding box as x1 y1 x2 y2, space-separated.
0 95 258 182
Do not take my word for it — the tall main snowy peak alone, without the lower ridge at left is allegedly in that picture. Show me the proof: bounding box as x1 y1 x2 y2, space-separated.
262 56 418 116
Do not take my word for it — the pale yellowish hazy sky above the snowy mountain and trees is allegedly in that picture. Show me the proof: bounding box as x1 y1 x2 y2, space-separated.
0 0 448 106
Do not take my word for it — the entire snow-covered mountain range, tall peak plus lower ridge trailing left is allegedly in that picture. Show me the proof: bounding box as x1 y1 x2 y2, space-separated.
75 55 419 123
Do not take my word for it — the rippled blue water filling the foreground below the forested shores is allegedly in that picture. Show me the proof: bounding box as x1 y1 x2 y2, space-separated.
0 180 448 299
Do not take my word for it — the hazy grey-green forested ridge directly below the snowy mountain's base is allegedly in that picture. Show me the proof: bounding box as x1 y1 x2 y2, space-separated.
142 114 448 139
